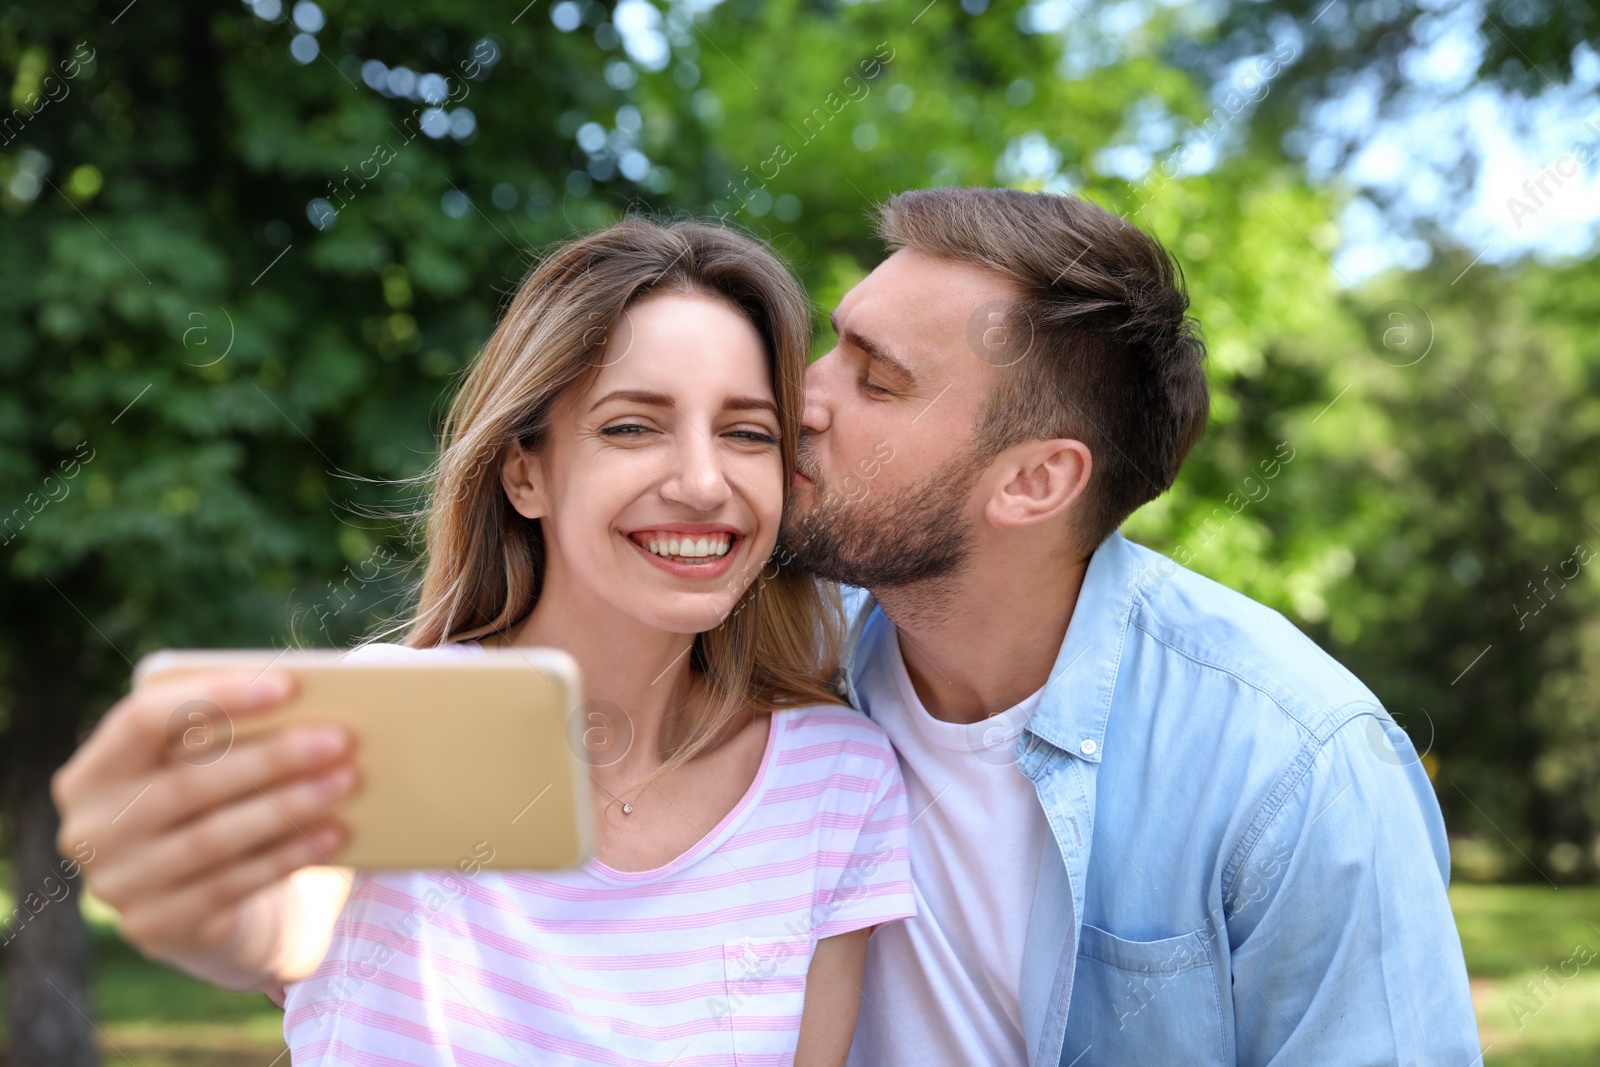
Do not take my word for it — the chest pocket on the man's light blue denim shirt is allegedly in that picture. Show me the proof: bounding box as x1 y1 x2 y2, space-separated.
1066 923 1230 1067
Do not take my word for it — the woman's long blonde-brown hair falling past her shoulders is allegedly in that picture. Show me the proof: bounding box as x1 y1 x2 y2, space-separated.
385 218 842 767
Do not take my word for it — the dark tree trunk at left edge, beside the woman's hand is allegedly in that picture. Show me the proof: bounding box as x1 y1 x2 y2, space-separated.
0 629 99 1067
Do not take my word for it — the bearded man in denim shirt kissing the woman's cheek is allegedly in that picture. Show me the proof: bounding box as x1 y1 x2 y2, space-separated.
784 189 1480 1067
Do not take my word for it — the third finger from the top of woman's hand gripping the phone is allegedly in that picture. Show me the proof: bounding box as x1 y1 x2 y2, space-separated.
93 763 358 907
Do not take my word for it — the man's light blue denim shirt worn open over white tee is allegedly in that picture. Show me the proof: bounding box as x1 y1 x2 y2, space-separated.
842 533 1480 1067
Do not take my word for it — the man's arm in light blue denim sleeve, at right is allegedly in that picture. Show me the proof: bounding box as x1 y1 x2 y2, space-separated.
1224 713 1480 1067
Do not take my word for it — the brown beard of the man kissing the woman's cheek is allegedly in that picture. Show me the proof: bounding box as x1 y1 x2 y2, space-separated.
778 443 989 590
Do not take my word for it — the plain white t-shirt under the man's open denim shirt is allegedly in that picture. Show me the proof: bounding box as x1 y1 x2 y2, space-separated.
850 622 1050 1067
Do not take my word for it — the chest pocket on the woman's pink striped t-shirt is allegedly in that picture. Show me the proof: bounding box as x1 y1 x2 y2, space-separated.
722 936 816 1064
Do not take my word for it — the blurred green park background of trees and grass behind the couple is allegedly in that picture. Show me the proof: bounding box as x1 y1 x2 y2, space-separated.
0 0 1600 1067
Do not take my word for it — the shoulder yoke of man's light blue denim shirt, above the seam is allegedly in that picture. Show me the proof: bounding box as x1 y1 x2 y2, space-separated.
1126 542 1382 741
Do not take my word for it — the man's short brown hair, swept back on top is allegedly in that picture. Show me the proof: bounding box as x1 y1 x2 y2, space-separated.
878 189 1210 552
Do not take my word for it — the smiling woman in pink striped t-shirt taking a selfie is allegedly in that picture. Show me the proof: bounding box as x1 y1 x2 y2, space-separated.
56 219 915 1064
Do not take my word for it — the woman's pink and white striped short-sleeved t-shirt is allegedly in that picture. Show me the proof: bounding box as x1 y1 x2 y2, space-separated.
283 645 917 1067
